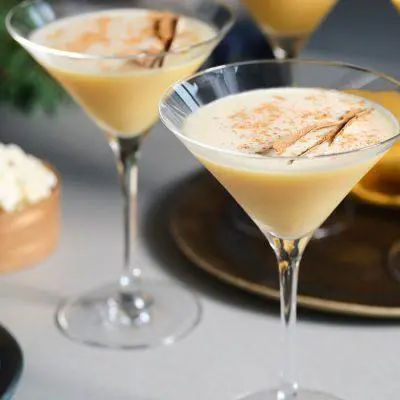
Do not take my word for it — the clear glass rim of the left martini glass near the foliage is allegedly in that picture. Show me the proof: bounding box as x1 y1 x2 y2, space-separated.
5 0 235 61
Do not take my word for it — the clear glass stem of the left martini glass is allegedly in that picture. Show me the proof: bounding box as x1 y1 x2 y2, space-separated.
108 137 141 303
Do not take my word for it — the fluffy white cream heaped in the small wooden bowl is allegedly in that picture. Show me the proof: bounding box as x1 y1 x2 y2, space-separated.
0 143 57 212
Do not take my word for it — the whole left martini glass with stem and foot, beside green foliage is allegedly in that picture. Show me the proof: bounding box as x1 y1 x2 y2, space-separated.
6 0 233 348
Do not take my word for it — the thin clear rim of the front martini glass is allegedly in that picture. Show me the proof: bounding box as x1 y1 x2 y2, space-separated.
158 58 400 162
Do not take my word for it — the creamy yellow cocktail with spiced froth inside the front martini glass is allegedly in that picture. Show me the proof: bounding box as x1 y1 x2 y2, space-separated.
184 88 396 239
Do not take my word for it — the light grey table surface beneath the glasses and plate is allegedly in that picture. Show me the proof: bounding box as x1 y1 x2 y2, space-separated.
0 0 400 400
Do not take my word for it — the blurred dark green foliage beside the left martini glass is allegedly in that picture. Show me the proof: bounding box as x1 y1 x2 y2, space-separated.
0 0 68 113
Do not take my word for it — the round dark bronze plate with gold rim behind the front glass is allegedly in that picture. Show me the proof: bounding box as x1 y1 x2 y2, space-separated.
171 172 400 318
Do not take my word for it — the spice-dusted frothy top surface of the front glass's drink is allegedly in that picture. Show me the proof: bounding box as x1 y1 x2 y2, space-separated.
185 88 393 157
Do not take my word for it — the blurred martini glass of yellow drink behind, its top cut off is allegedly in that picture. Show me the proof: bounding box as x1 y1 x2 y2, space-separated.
242 0 338 60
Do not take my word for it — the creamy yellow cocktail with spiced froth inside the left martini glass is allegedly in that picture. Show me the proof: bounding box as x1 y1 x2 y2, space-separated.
30 9 216 136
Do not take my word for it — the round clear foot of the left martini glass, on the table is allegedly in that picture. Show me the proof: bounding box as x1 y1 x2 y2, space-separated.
56 280 201 349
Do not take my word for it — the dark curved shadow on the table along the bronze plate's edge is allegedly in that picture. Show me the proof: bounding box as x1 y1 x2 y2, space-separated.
141 176 400 327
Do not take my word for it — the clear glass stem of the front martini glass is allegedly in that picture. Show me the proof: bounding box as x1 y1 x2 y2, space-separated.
267 234 311 400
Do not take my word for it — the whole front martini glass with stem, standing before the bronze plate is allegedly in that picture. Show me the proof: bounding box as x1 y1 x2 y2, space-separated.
160 60 400 400
